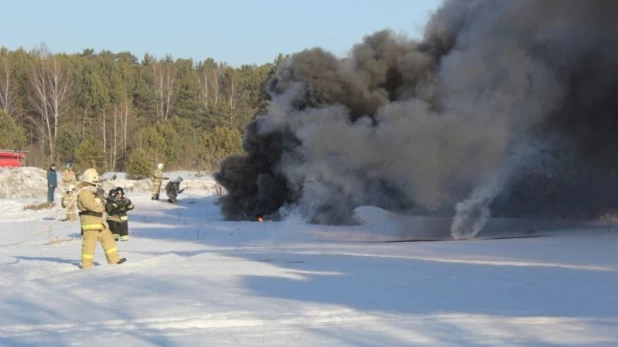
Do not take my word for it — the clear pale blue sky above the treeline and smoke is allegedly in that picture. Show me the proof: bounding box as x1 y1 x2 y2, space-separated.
0 0 442 66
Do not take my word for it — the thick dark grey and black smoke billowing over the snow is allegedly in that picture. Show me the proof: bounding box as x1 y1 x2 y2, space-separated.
216 0 618 237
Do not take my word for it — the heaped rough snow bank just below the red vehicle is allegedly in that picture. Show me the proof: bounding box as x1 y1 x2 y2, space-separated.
0 167 48 199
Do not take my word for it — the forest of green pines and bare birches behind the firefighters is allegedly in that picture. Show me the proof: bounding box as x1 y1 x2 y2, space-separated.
0 44 284 176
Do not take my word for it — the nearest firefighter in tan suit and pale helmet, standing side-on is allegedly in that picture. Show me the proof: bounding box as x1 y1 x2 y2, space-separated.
77 169 126 269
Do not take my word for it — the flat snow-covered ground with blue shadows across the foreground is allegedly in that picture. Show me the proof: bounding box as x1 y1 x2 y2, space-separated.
0 190 618 347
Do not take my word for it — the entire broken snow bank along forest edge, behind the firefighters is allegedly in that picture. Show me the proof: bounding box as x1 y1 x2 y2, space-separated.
0 167 217 199
